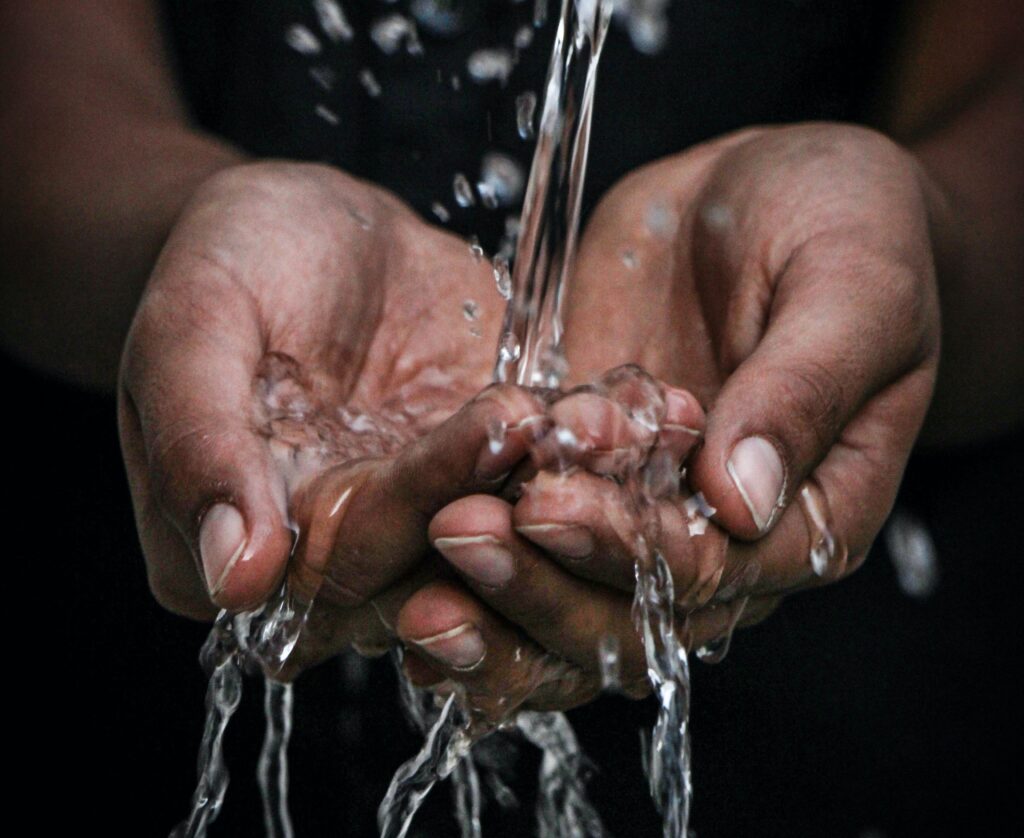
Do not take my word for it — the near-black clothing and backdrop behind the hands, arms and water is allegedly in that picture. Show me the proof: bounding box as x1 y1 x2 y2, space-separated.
9 0 1024 838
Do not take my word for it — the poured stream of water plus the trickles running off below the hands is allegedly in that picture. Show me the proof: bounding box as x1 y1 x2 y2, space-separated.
172 0 708 838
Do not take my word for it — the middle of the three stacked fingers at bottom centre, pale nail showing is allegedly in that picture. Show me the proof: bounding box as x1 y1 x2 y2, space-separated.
429 496 646 680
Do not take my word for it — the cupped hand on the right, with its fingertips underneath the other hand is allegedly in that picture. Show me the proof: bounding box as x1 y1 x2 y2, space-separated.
398 125 939 706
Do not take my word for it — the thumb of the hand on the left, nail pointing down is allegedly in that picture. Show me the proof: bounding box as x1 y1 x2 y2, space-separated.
121 258 292 610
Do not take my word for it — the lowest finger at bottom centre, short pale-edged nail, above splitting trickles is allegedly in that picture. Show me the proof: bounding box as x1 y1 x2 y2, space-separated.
397 582 598 719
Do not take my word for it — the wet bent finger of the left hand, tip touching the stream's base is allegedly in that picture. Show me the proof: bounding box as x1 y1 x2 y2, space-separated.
296 385 543 607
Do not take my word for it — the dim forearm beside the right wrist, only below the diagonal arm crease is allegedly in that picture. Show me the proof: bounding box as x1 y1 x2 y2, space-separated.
911 61 1024 443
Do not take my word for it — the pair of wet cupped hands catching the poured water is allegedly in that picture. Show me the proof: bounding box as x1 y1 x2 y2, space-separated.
119 124 939 714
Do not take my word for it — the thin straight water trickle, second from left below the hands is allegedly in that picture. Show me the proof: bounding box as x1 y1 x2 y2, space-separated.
256 678 295 838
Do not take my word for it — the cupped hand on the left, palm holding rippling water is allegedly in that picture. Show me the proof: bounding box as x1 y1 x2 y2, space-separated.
119 163 543 659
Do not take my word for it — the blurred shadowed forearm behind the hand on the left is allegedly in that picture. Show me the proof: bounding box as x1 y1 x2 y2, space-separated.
0 0 239 387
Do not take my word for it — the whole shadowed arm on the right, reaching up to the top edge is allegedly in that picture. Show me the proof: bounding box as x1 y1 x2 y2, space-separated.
881 0 1024 444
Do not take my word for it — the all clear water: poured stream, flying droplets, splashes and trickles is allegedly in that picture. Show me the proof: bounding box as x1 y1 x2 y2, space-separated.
172 0 846 838
